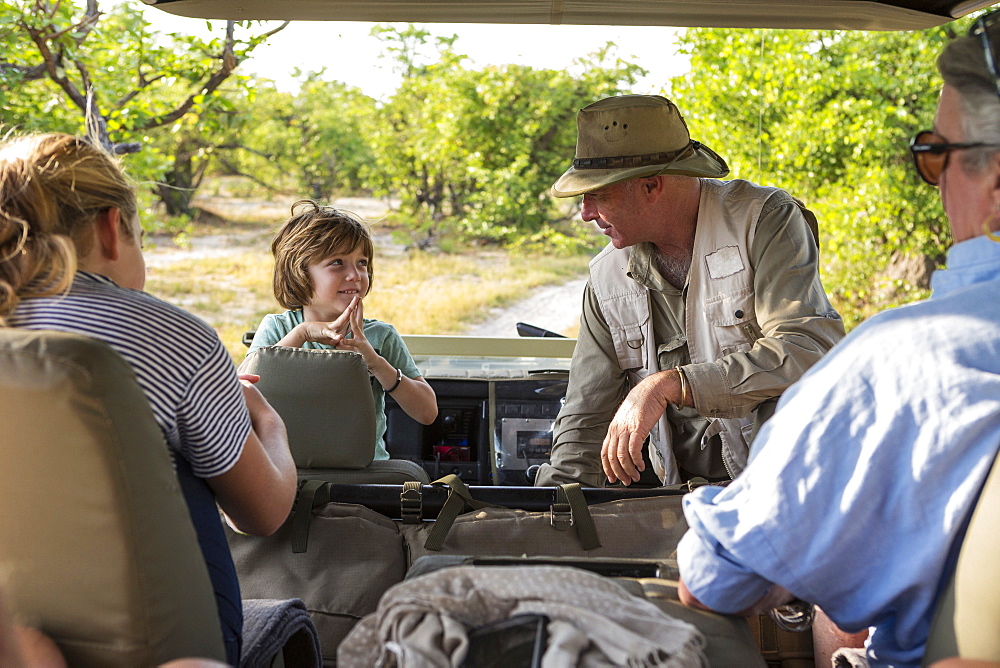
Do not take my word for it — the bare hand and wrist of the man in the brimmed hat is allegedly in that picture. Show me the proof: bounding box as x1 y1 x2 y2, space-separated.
601 369 681 485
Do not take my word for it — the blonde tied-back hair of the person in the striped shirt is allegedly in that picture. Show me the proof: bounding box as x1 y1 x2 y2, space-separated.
0 134 137 326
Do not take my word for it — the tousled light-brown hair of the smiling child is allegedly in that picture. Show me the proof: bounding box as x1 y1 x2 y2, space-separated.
271 199 375 310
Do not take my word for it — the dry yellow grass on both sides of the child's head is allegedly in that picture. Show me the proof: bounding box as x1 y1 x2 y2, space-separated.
146 249 589 360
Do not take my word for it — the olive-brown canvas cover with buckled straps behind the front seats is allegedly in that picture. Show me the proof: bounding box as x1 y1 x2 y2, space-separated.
227 477 704 665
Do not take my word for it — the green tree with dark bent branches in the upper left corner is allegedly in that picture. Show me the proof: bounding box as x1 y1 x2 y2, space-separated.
0 0 287 219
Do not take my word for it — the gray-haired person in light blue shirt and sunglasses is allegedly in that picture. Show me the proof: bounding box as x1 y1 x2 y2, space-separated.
678 14 1000 666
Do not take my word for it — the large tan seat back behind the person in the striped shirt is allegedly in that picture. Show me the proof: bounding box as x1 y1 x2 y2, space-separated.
0 329 226 666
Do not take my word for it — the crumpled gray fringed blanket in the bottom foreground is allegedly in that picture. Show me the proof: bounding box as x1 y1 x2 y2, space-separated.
337 566 707 668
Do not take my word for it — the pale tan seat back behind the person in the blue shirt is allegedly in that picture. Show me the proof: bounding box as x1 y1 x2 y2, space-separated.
924 448 1000 666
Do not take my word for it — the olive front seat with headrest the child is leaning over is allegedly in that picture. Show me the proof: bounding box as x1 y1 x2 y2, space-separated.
242 346 430 484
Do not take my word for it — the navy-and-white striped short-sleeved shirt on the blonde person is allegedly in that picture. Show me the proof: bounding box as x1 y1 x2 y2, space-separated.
9 271 250 478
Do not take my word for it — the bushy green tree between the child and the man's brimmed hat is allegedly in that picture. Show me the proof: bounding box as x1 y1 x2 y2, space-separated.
372 27 643 245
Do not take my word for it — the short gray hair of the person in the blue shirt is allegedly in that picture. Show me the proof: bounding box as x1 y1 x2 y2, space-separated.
937 19 1000 173
